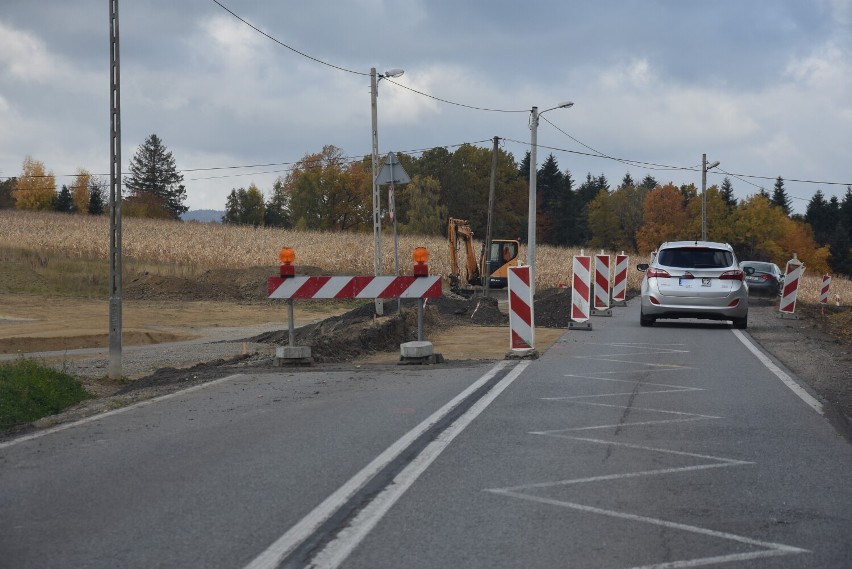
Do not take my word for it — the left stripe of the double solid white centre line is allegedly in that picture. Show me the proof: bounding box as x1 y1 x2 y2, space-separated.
245 361 525 569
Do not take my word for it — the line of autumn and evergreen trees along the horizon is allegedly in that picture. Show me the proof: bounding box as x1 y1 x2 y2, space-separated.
0 134 852 275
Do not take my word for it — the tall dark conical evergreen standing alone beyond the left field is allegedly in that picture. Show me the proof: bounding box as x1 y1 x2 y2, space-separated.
124 134 189 219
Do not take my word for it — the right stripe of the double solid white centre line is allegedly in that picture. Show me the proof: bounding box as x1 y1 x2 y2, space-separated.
309 361 530 569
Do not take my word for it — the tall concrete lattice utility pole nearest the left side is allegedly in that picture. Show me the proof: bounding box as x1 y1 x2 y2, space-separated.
108 0 122 379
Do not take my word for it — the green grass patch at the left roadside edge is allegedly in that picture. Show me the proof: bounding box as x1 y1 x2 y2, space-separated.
0 358 94 429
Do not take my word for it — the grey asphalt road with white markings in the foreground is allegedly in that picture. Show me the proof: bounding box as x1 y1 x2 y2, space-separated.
0 304 852 569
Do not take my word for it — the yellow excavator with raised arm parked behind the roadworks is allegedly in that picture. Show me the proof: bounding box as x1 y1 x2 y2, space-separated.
447 217 521 292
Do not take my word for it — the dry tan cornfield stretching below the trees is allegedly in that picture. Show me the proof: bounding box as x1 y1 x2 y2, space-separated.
0 210 852 305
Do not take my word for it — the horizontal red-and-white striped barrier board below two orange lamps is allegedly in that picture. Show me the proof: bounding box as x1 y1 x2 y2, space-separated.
267 275 441 298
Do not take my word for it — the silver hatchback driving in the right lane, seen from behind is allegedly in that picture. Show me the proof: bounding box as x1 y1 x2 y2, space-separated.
637 241 748 329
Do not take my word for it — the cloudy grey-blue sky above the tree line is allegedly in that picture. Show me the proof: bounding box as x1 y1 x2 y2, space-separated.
0 0 852 213
